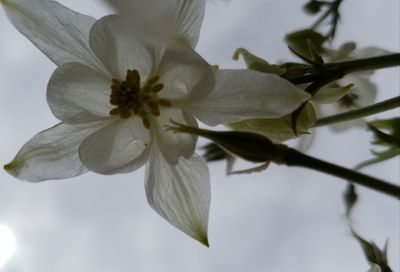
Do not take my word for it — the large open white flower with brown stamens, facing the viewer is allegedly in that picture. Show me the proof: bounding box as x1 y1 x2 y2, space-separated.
3 0 309 245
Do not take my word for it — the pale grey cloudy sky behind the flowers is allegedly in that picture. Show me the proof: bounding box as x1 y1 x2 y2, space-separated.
0 0 400 272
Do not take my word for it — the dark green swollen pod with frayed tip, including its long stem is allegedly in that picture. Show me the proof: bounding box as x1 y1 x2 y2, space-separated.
173 124 400 199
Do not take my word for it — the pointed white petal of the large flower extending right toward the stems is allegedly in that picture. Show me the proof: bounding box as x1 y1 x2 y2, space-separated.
189 70 310 126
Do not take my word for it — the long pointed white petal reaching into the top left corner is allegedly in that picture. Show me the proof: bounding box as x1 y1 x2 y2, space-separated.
2 0 104 71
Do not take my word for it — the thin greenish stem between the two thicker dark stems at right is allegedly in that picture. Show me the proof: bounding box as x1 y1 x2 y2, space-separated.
313 96 400 127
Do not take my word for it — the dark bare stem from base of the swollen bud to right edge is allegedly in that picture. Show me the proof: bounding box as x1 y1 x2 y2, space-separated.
284 148 400 199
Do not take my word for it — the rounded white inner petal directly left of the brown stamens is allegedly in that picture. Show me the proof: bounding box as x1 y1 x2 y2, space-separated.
47 63 113 123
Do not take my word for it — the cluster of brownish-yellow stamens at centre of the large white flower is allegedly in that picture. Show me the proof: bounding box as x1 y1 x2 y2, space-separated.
110 70 172 128
